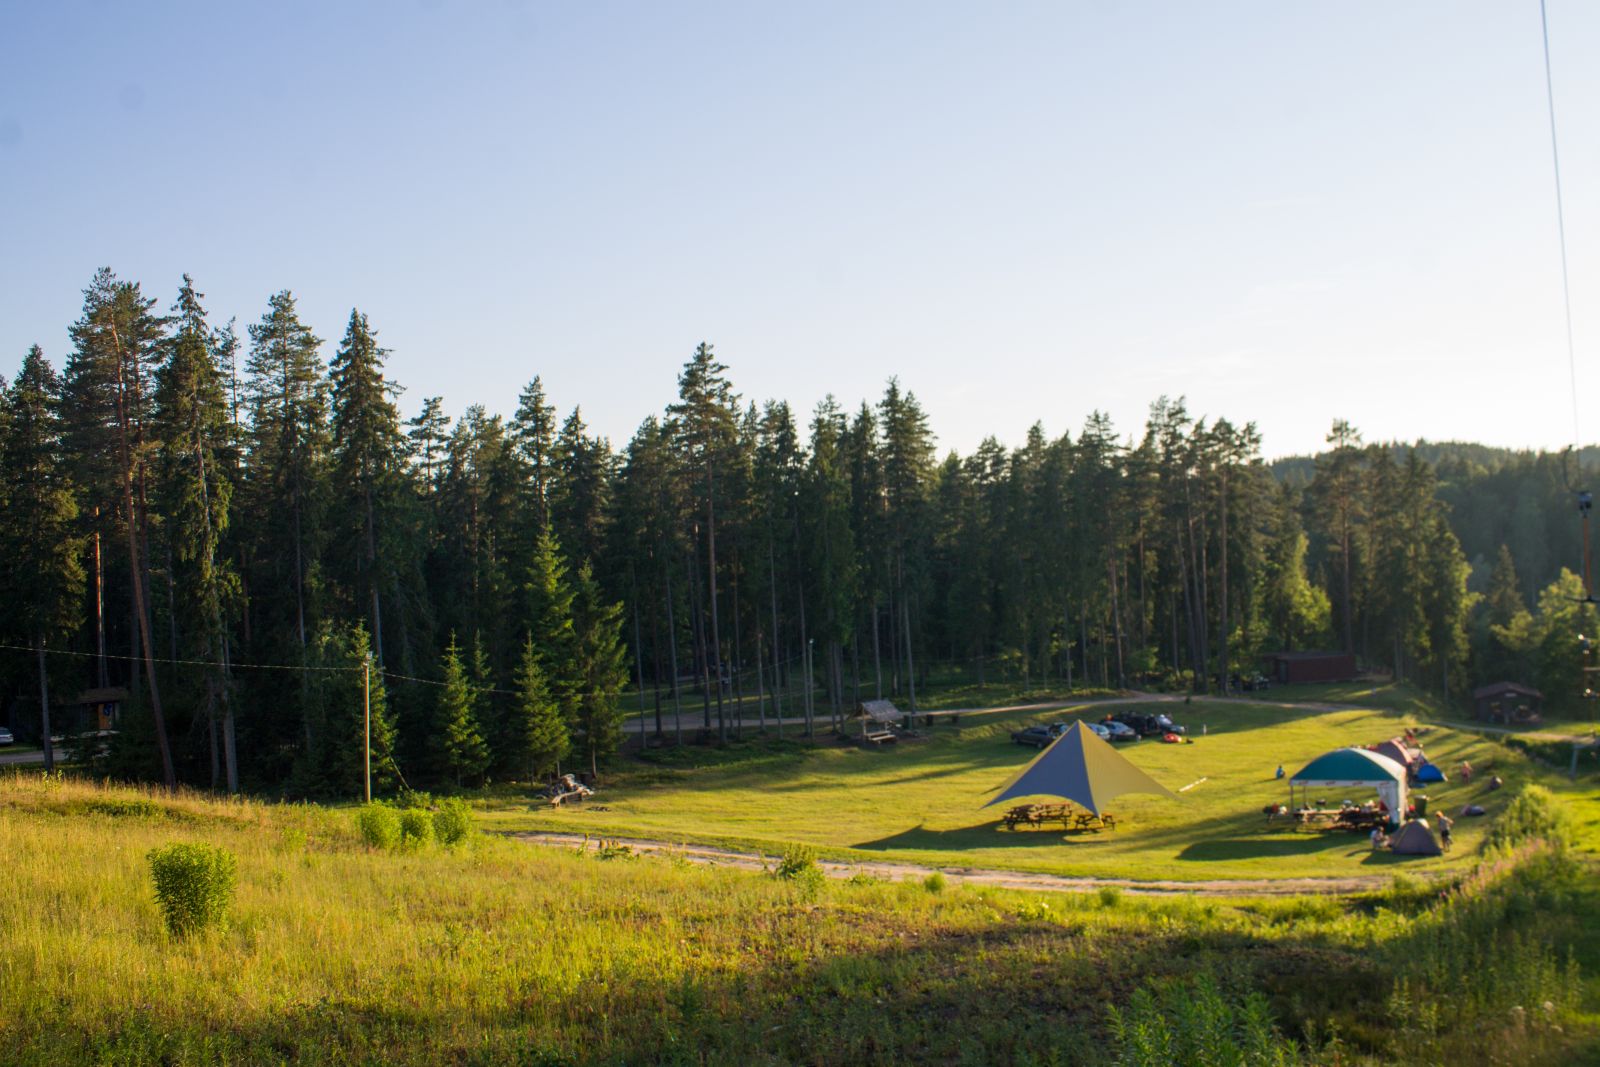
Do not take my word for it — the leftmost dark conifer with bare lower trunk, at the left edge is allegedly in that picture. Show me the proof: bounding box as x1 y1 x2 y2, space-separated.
0 344 83 771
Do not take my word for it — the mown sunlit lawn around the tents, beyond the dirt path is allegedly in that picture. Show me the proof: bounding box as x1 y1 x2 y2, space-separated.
480 691 1600 880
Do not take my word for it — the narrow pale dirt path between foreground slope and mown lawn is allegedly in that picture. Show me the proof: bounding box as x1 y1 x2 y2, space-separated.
510 833 1392 897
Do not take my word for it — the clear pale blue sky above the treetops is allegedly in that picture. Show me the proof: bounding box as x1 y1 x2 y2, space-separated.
0 0 1600 456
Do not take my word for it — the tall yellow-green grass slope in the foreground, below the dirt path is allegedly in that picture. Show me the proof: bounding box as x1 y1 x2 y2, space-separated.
0 774 1600 1065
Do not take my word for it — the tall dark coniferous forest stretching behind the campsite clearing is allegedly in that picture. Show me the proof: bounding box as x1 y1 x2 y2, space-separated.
0 270 1592 797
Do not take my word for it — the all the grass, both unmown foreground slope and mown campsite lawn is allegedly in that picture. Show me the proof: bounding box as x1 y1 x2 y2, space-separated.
0 684 1600 1067
